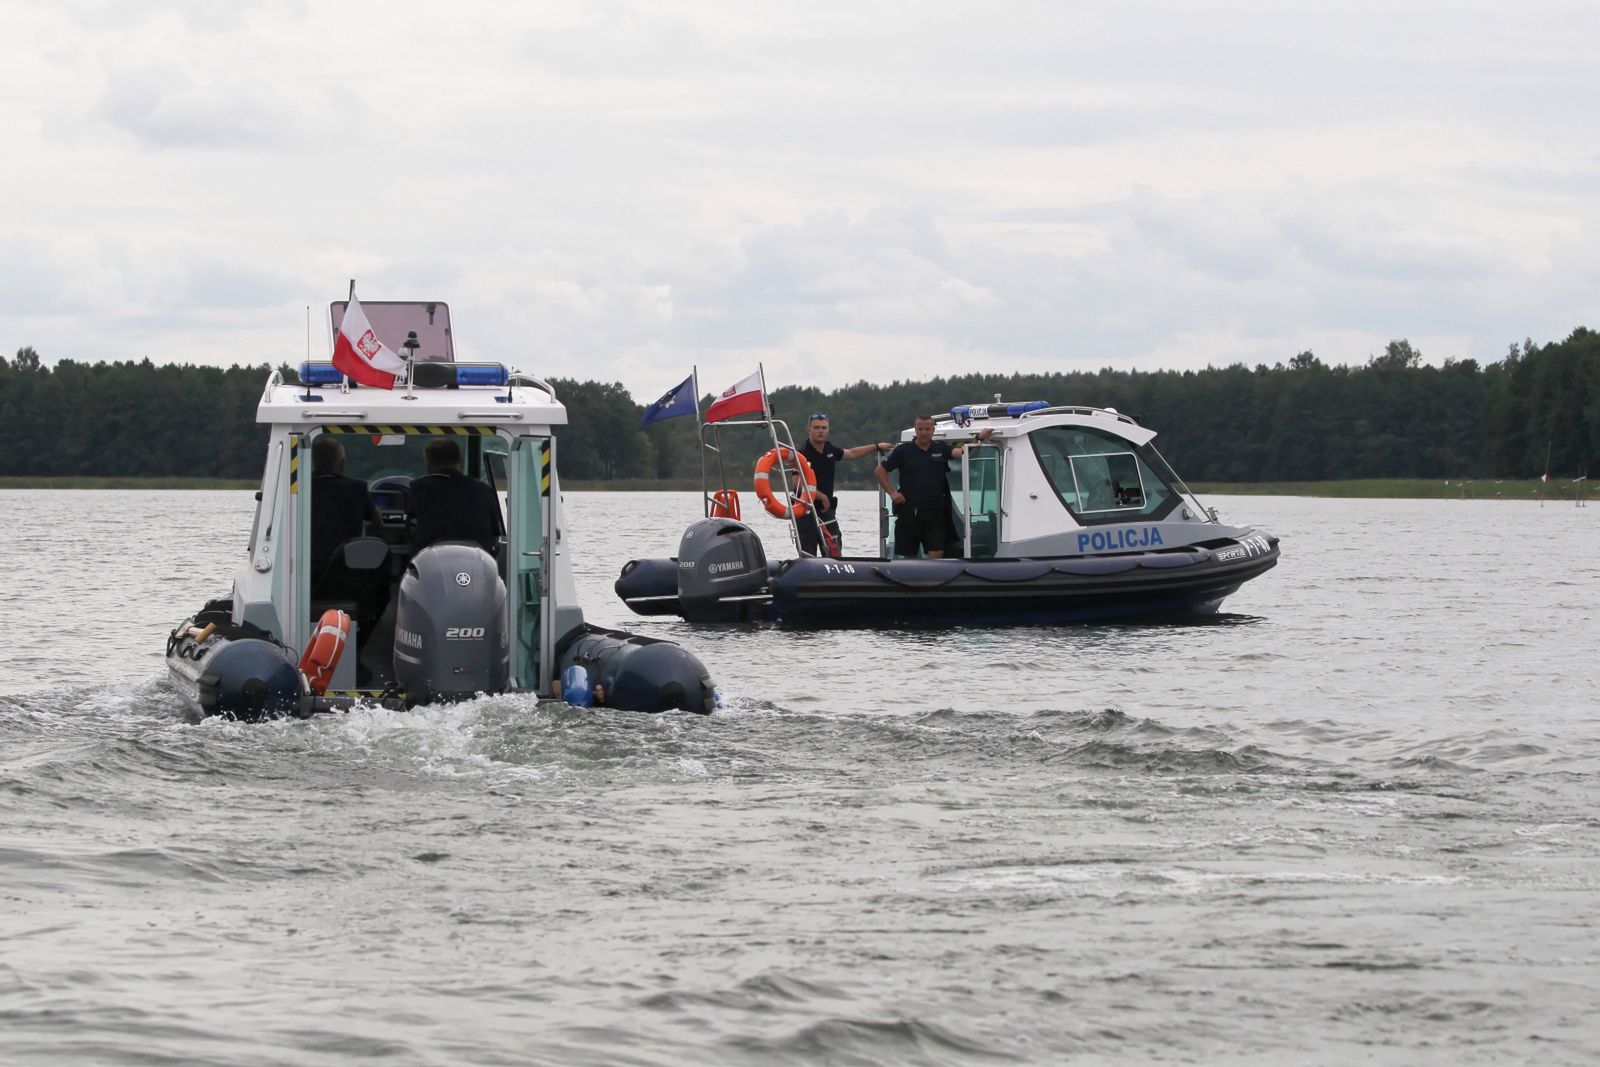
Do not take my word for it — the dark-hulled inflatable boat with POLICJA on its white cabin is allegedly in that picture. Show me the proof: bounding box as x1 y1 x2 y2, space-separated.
616 397 1278 627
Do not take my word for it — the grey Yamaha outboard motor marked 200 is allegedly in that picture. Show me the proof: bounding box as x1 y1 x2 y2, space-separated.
395 541 510 704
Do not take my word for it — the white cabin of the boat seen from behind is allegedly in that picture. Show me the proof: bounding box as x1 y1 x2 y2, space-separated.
232 301 582 693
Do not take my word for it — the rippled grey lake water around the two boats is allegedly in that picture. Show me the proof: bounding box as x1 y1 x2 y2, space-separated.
0 491 1600 1065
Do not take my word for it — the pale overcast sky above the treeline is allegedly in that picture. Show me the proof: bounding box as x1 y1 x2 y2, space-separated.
0 0 1600 402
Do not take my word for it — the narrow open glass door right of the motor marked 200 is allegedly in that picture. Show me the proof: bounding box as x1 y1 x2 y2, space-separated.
506 437 550 694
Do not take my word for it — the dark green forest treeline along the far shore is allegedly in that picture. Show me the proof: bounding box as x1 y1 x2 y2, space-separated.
0 328 1600 486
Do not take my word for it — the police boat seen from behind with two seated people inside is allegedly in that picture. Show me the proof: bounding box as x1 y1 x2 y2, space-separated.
166 301 717 720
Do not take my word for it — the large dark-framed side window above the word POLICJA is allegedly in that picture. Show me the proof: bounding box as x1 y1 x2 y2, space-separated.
1029 426 1178 526
